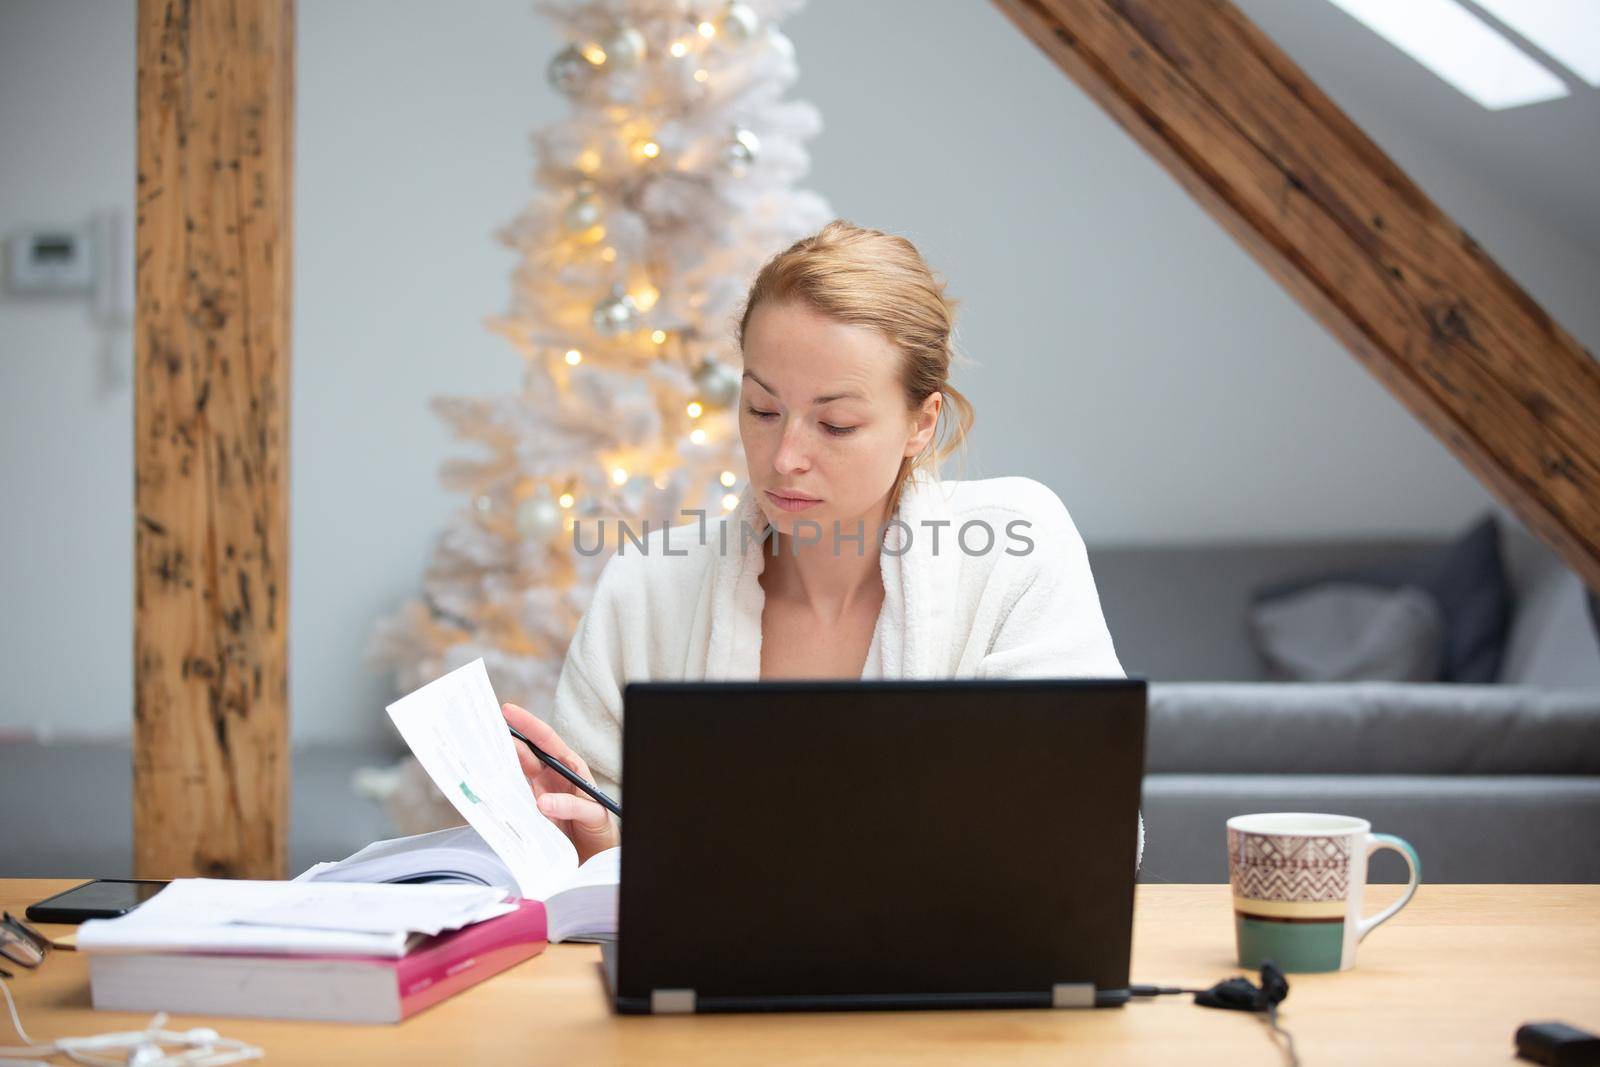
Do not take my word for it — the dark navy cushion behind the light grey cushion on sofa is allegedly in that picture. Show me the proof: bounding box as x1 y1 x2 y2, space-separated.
1254 515 1512 681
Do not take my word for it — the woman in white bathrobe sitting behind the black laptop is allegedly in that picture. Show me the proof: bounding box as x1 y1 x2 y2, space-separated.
502 221 1144 859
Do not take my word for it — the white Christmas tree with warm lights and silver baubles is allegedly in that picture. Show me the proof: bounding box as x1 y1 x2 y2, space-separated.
370 0 832 825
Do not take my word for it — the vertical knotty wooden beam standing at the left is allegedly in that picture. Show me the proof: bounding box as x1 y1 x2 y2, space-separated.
133 0 294 878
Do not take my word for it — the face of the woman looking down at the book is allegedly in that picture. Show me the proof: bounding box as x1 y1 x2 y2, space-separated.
739 302 942 550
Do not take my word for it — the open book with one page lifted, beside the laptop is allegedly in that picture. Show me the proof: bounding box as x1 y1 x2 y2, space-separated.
296 659 621 941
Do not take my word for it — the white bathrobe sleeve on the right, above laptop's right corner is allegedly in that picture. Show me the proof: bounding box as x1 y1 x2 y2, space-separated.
979 483 1144 870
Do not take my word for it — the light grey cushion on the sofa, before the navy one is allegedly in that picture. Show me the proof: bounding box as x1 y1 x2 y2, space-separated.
1248 582 1443 681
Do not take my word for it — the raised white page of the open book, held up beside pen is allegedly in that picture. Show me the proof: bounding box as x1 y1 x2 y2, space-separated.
389 659 578 901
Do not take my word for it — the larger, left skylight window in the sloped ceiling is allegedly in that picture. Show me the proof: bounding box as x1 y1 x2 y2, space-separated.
1330 0 1566 110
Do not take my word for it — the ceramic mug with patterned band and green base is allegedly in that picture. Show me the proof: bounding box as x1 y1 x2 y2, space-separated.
1227 811 1422 973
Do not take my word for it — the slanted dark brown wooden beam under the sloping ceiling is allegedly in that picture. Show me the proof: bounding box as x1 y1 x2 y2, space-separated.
995 0 1600 590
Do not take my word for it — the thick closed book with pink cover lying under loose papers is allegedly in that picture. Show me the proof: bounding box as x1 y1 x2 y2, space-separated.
90 901 547 1022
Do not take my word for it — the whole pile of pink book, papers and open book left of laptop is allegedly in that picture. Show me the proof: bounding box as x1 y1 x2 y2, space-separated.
77 659 621 1022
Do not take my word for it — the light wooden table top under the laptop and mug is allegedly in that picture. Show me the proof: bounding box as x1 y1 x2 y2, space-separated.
0 880 1600 1067
